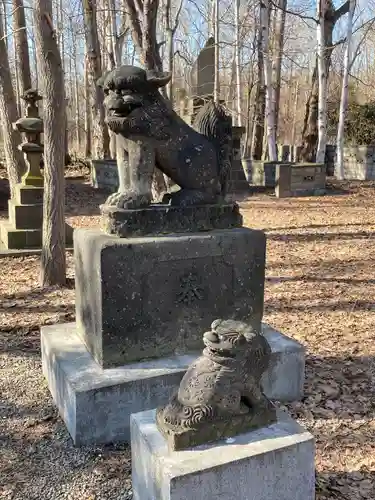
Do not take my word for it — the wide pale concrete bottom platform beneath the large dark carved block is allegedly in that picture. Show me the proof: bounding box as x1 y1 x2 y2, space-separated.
41 323 305 445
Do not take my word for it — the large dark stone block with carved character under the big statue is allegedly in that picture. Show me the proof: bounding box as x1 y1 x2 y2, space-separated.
74 228 266 368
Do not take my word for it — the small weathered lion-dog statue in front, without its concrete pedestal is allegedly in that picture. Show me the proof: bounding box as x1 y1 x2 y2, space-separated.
156 320 276 451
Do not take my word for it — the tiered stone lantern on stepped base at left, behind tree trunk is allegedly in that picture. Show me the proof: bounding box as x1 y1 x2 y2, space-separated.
0 89 73 250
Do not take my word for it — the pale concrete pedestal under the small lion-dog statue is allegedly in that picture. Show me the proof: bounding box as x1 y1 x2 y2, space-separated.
131 410 315 500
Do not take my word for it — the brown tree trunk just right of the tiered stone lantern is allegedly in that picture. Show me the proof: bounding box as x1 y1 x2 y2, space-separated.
34 0 66 286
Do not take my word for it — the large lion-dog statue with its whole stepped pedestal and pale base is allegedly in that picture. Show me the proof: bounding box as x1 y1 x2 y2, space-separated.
41 66 304 444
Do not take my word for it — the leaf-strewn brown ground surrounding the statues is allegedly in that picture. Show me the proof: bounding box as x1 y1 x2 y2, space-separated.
0 175 375 500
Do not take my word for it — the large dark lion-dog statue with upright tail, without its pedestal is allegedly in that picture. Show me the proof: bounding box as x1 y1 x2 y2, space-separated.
101 66 232 208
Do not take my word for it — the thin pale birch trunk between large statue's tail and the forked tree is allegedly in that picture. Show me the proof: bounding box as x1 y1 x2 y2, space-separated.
260 0 277 161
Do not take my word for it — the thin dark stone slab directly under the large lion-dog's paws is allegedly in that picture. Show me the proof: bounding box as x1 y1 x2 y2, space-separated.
100 203 242 238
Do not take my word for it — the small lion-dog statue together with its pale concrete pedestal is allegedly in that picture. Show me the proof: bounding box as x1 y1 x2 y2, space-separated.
131 320 315 500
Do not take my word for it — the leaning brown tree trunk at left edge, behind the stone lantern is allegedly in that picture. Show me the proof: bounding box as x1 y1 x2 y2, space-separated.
0 5 26 196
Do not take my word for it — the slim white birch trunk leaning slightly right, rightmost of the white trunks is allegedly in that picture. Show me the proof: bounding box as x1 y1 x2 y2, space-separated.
335 0 356 179
